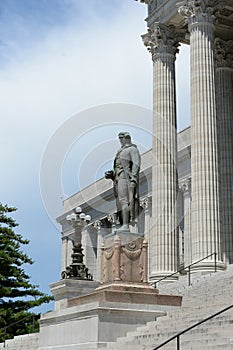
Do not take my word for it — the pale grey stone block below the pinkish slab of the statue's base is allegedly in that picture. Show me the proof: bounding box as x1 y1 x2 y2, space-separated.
39 298 178 350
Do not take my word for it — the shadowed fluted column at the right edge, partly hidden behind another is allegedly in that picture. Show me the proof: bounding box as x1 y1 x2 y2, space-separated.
215 38 233 264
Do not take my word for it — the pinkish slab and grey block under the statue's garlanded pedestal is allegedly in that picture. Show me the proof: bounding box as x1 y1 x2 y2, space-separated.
39 281 182 350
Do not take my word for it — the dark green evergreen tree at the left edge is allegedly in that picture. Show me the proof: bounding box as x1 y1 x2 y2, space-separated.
0 203 52 342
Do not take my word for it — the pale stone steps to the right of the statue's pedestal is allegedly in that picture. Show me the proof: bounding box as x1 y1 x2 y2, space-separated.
106 265 233 350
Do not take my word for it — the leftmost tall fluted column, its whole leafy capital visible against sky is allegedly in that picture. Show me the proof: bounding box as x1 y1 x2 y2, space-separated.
142 23 179 280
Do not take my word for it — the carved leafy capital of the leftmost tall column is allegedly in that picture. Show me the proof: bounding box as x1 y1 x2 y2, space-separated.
142 22 183 61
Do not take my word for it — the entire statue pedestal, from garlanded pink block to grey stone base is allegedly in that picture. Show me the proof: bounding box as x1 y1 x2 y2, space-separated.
39 232 182 350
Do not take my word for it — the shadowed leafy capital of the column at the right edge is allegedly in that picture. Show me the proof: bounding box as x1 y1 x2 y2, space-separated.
215 38 233 68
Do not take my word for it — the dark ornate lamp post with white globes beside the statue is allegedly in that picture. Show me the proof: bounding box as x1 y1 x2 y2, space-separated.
61 207 93 280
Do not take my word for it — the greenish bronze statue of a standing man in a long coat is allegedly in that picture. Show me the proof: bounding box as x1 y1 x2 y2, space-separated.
105 132 141 231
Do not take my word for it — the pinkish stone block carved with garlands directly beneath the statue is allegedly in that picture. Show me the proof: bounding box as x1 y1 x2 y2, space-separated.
101 236 147 283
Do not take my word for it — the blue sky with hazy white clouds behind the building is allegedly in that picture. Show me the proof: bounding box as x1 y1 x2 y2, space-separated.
0 0 189 311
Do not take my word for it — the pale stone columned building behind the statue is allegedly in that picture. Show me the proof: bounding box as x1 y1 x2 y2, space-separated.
58 0 233 281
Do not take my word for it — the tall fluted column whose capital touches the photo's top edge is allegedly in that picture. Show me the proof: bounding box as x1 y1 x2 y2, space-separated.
179 0 226 270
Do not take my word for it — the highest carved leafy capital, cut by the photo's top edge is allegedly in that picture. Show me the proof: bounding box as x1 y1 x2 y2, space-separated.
178 0 222 29
